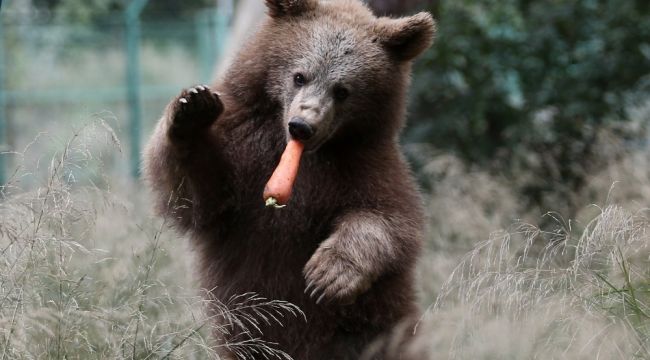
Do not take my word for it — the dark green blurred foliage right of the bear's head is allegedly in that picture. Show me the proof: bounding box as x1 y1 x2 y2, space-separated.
406 0 650 214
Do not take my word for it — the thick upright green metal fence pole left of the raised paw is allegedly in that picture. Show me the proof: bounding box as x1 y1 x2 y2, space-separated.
125 0 148 178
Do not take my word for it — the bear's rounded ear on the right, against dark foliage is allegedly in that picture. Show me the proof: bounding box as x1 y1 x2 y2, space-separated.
375 12 436 61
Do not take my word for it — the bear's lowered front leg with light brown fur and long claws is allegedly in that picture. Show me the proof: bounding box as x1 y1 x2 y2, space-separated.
304 211 414 304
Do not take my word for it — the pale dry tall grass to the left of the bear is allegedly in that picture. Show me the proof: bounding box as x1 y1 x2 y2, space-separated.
0 119 302 359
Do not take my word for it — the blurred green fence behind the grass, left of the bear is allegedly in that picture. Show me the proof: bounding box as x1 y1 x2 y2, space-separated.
0 1 231 184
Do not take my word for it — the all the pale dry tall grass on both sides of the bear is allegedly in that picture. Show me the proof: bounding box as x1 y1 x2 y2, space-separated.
0 114 650 360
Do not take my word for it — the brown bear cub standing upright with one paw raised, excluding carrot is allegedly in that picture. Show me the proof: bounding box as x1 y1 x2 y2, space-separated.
144 0 435 360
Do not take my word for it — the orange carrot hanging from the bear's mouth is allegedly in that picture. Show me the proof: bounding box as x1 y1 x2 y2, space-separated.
264 139 305 208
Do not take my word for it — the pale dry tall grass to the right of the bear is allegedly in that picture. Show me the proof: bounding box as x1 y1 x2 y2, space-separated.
410 142 650 359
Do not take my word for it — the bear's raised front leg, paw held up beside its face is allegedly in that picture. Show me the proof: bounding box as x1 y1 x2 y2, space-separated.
144 86 227 230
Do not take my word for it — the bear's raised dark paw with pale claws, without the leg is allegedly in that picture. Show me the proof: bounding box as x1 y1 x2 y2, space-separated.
169 85 223 140
